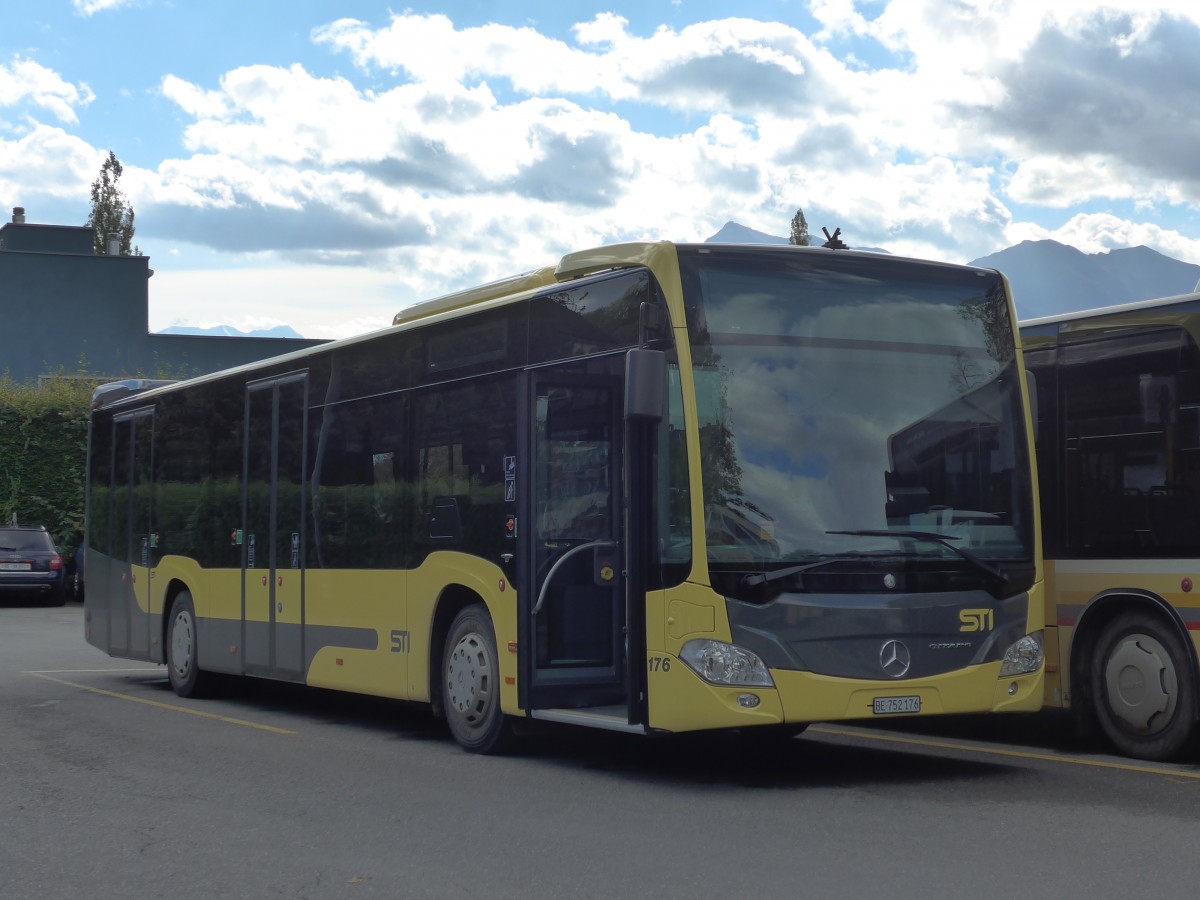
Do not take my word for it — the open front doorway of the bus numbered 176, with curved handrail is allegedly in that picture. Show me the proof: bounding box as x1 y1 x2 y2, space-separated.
518 373 626 714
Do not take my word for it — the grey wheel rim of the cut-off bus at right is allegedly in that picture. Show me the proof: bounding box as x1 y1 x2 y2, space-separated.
1104 635 1180 734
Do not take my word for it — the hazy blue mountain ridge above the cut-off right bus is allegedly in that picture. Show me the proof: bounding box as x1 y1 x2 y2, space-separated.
971 240 1200 319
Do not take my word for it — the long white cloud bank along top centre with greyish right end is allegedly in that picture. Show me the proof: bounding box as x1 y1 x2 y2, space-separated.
313 13 833 113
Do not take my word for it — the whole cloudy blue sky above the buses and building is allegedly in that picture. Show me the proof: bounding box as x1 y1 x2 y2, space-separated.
0 0 1200 337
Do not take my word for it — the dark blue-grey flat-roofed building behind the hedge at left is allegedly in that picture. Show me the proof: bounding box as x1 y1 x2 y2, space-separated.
0 215 323 382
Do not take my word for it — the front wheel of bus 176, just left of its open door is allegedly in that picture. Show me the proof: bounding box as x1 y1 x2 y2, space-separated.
442 604 512 754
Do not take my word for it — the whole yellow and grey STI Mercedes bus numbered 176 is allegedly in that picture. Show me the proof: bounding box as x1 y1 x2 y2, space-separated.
85 242 1044 752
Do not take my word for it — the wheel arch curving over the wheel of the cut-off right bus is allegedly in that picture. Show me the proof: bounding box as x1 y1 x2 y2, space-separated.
1070 588 1200 725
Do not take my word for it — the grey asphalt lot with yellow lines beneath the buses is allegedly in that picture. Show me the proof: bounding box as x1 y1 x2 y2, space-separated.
0 604 1200 900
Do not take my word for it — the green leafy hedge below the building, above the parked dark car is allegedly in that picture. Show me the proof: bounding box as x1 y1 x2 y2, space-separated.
0 374 97 559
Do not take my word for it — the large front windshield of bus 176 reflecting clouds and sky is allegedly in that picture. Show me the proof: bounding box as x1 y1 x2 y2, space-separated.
680 248 1033 593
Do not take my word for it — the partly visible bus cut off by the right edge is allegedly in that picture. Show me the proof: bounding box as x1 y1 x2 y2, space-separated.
1021 286 1200 760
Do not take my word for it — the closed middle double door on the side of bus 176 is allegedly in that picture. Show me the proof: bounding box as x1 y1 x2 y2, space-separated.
242 373 307 680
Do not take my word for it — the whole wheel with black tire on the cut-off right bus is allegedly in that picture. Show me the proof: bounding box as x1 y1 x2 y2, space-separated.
1091 612 1196 760
